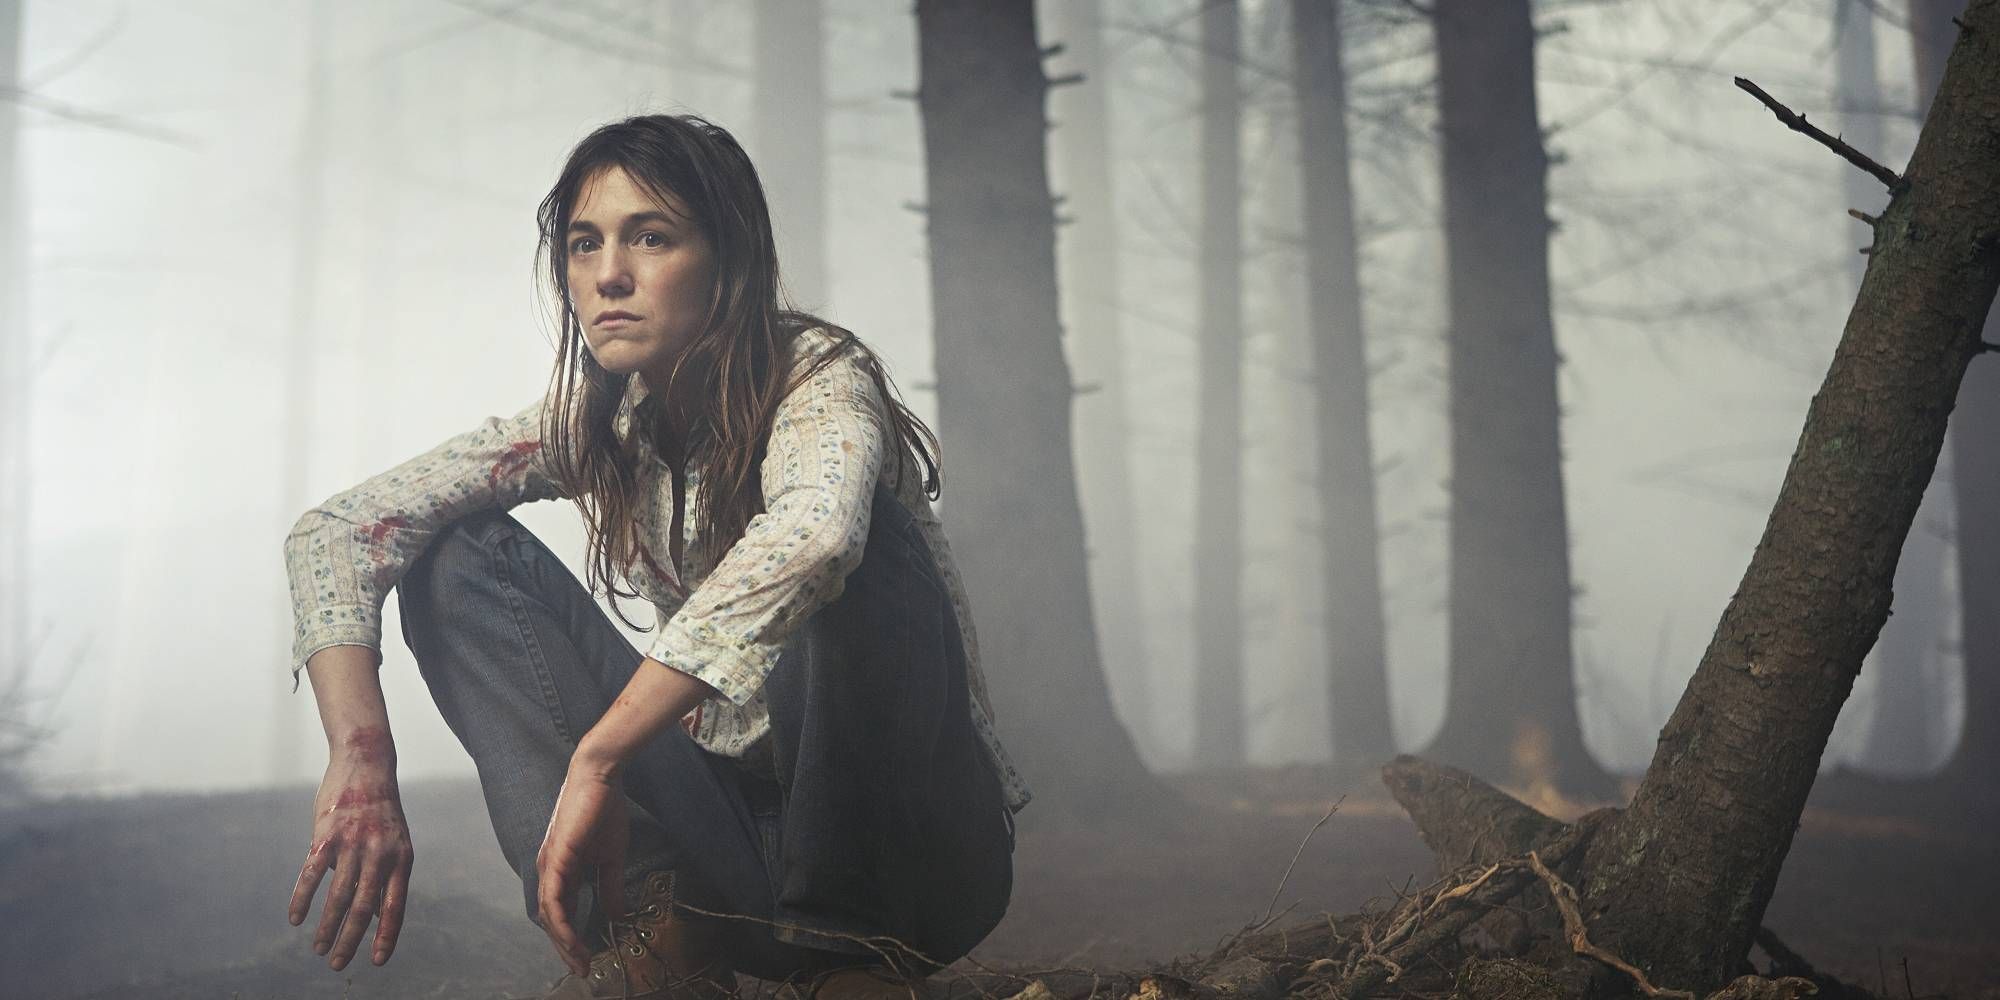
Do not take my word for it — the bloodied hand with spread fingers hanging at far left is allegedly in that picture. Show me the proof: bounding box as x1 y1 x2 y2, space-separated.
288 728 416 970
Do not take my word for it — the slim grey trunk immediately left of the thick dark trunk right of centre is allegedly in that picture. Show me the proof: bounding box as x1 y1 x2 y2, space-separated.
1292 0 1396 768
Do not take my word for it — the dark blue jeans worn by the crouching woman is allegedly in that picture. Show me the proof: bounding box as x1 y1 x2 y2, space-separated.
398 486 1014 978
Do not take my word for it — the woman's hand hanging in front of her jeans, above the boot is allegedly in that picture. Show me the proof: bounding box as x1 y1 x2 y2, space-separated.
534 750 632 976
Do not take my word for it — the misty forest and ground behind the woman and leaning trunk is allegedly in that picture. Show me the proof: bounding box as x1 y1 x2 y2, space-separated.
11 0 2000 996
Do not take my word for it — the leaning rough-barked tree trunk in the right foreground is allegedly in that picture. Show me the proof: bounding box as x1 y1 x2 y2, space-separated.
1578 0 2000 994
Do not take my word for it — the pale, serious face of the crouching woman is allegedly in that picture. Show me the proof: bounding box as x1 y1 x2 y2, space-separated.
564 166 716 390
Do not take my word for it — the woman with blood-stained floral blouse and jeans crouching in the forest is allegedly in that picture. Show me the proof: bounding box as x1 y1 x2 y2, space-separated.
286 116 1028 996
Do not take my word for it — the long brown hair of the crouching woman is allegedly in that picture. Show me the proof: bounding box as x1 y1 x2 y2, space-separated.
536 114 942 626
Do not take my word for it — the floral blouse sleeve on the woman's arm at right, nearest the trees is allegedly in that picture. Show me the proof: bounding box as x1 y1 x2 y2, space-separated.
646 342 886 706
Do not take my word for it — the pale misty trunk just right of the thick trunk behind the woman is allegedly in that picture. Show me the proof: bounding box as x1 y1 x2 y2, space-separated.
1052 0 1154 746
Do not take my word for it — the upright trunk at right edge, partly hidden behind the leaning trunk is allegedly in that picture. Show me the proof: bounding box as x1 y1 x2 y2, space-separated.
1910 0 2000 820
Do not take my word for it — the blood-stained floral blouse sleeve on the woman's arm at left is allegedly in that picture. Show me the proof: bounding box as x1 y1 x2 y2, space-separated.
284 400 564 690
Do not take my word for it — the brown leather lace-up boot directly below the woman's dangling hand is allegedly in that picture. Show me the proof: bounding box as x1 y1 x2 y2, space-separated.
542 872 736 1000
